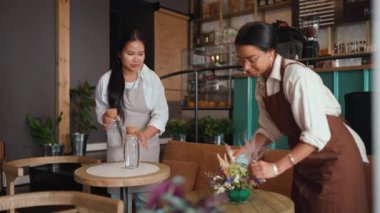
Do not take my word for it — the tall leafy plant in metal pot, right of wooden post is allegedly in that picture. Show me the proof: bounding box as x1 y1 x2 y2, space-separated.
70 81 97 156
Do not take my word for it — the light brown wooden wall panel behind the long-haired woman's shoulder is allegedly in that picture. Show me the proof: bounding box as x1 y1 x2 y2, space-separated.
154 9 188 101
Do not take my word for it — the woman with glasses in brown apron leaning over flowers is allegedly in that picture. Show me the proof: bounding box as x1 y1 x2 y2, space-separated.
235 22 369 213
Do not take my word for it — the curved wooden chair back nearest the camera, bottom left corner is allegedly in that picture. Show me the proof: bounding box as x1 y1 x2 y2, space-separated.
0 191 124 213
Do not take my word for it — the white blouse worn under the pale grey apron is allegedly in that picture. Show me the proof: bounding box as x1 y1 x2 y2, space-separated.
95 64 169 134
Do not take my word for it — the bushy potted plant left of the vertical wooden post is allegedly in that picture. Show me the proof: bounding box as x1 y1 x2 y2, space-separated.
25 112 63 156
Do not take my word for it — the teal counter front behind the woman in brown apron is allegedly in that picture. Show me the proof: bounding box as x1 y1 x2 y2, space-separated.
232 68 372 149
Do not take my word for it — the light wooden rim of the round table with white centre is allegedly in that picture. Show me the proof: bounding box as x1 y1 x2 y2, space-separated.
74 162 170 187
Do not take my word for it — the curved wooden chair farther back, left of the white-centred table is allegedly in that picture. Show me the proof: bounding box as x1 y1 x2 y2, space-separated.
4 156 101 195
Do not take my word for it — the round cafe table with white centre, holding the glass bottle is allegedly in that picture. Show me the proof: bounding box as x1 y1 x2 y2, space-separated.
74 162 170 212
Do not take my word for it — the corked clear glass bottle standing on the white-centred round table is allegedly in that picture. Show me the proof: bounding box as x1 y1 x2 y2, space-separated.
124 127 140 169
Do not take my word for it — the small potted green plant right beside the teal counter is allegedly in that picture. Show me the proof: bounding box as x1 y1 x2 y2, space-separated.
199 116 232 145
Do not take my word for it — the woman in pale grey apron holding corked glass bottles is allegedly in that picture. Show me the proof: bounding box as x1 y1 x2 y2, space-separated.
96 30 168 207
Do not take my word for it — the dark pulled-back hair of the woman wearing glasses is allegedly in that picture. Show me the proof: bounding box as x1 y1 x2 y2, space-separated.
235 22 277 51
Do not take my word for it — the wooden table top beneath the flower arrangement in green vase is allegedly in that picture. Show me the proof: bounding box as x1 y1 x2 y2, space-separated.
186 189 294 213
